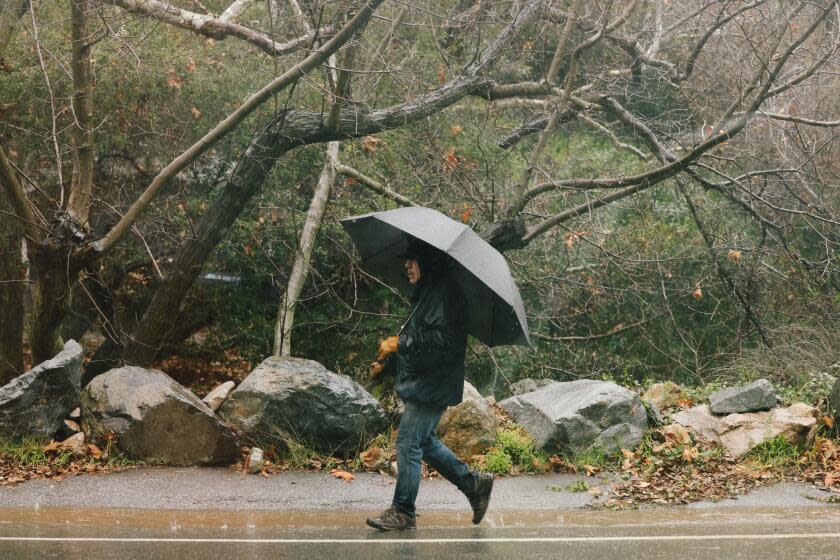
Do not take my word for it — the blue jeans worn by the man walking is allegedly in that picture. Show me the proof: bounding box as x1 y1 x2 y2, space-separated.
392 401 476 516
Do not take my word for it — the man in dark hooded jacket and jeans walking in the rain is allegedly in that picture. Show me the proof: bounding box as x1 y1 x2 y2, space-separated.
367 241 493 531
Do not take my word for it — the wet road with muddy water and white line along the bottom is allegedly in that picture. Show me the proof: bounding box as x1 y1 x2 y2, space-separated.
0 507 840 560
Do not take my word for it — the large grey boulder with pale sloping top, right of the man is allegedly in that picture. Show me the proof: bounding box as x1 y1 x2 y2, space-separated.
499 379 648 453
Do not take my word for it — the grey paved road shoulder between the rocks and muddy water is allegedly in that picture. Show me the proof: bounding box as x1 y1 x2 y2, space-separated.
0 467 837 512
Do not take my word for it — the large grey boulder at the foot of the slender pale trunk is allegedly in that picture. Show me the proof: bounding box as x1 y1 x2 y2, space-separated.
219 356 388 454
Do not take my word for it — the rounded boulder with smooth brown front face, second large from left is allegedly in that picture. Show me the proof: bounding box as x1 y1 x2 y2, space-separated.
81 366 239 465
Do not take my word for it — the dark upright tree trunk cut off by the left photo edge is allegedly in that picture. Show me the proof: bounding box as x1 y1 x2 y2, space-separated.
0 203 26 386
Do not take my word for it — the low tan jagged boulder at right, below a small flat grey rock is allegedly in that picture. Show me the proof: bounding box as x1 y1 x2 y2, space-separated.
674 403 817 457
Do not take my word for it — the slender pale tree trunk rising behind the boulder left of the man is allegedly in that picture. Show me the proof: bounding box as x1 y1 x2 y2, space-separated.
274 142 339 356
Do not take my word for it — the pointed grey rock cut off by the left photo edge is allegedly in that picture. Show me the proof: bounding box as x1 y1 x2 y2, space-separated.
0 340 82 439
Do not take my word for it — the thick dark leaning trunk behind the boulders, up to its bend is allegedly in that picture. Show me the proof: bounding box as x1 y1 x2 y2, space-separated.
123 118 289 365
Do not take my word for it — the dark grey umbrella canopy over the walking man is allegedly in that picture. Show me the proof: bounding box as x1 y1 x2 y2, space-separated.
341 207 531 346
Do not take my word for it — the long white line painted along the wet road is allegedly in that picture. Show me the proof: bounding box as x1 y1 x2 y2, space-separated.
0 533 840 544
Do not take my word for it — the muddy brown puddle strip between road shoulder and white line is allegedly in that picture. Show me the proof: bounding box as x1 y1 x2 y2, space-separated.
0 507 840 538
